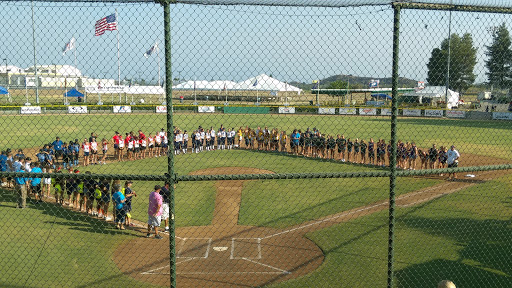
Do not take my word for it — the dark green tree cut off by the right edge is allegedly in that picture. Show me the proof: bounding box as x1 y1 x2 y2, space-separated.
485 23 512 89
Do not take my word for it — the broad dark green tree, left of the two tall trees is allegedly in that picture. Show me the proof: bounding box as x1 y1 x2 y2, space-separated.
427 33 477 92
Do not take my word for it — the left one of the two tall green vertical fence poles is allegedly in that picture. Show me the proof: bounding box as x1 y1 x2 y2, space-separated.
163 0 176 288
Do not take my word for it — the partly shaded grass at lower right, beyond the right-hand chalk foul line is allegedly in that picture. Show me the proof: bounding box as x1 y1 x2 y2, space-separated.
272 175 512 288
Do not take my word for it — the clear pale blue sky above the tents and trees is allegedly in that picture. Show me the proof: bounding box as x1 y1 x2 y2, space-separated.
0 2 512 83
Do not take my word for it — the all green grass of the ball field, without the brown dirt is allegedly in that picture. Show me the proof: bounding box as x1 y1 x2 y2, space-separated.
0 113 512 287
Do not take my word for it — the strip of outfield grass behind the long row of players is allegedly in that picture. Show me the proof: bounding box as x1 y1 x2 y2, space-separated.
0 113 512 160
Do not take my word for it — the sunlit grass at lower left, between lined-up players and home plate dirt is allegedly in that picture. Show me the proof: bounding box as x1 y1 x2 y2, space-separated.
0 190 161 287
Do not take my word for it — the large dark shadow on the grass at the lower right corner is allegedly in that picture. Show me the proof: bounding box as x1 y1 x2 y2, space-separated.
396 217 512 288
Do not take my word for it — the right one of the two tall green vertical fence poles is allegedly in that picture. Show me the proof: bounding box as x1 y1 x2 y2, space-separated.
387 6 400 288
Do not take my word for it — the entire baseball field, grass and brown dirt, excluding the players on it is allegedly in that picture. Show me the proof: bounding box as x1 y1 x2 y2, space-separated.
0 113 512 287
